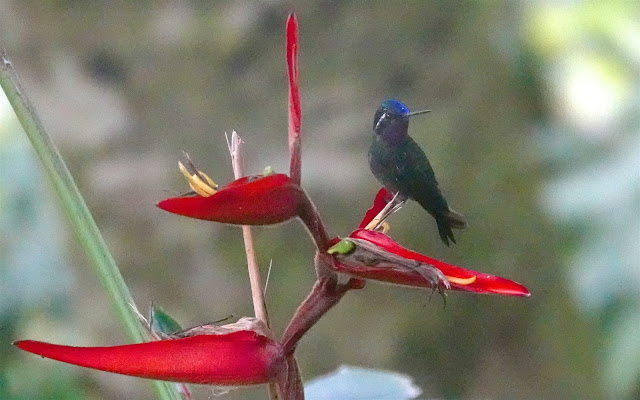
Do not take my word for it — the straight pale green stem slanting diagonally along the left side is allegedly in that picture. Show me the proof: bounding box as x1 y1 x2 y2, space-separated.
0 47 181 400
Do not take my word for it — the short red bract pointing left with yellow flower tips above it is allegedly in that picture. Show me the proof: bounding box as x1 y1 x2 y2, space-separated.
158 174 308 225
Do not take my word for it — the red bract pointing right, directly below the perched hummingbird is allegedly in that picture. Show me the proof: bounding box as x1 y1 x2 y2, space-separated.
334 229 530 296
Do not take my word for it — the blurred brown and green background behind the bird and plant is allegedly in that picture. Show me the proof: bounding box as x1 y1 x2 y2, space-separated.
0 0 640 399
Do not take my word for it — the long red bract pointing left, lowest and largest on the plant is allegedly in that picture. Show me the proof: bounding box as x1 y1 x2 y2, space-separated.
14 318 286 386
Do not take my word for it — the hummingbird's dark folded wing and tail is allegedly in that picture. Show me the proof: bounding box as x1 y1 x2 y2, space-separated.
396 137 466 246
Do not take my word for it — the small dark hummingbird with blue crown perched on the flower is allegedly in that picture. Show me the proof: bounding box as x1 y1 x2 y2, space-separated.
369 99 467 246
